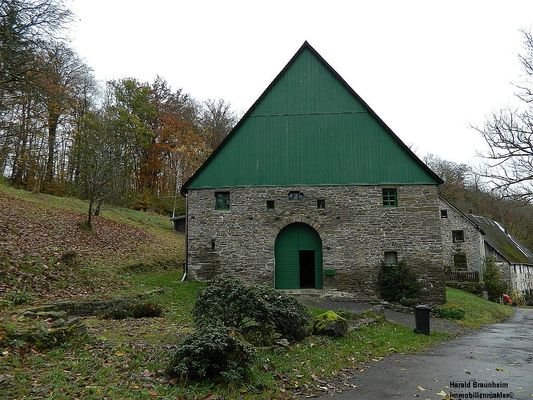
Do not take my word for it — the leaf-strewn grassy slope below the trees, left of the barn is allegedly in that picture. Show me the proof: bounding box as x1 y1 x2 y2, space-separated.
0 183 184 299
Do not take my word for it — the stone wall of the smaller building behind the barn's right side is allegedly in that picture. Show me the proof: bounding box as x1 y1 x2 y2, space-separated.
439 199 485 276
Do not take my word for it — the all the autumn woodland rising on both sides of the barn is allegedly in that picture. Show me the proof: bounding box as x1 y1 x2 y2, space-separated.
0 0 533 249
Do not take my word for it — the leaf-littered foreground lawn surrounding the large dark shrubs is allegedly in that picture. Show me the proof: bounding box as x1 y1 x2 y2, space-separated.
2 278 449 399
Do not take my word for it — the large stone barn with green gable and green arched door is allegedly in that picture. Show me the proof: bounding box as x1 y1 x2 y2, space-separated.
182 42 445 302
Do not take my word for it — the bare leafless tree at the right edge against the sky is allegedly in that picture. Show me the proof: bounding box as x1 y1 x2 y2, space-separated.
476 32 533 203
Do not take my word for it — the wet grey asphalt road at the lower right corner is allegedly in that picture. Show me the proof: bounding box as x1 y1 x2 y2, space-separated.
323 309 533 400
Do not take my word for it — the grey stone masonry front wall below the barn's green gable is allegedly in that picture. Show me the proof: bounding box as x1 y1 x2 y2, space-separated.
187 185 445 303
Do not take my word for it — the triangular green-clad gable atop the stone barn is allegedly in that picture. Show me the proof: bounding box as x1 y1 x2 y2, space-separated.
182 42 442 192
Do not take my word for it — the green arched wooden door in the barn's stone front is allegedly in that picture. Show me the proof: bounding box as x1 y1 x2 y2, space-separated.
275 223 322 289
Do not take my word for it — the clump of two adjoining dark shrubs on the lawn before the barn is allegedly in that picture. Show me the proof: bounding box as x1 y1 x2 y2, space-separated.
172 276 311 382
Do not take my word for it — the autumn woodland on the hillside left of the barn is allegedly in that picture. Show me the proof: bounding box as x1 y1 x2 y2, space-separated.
0 0 236 219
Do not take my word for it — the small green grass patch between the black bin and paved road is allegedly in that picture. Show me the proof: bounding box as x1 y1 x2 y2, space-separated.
446 288 513 328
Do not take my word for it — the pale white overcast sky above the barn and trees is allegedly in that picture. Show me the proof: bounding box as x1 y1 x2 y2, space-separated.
66 0 533 164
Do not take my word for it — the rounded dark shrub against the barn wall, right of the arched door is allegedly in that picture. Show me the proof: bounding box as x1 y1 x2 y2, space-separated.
378 261 422 302
